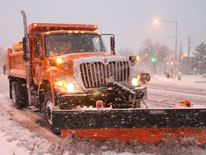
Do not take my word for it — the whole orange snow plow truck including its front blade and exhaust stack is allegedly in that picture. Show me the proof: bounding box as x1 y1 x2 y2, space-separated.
7 11 206 143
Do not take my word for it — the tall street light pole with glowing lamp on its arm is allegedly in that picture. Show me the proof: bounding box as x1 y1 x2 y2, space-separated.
154 19 177 77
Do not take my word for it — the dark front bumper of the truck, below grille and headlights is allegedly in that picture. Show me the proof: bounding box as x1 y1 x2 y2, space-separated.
58 85 147 109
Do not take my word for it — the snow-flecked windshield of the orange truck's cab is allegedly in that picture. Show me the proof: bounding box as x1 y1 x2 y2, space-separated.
45 33 106 57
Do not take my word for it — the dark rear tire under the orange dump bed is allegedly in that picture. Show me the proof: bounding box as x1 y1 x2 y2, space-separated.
11 80 27 109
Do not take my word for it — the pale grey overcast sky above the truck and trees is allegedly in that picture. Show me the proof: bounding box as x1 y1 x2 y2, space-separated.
0 0 206 55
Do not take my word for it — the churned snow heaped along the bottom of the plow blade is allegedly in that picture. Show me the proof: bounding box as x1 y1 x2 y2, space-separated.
58 135 206 155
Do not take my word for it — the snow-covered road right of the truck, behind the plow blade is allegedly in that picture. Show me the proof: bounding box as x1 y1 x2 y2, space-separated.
146 75 206 108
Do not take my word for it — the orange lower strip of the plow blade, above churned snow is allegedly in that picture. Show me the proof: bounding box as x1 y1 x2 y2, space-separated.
61 128 206 144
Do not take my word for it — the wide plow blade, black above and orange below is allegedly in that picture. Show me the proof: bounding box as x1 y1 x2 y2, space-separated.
52 108 206 144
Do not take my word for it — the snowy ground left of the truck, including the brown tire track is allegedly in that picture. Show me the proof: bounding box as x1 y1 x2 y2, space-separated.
0 74 59 155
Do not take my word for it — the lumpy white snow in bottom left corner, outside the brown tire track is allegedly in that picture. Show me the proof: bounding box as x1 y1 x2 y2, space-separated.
0 107 52 155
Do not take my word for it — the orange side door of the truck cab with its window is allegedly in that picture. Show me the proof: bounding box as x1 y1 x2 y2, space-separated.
32 36 44 84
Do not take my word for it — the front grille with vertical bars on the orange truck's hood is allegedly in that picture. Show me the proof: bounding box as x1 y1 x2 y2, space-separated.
80 61 129 88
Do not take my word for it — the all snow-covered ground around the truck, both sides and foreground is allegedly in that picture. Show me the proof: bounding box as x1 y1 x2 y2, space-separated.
0 74 206 155
